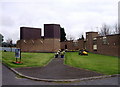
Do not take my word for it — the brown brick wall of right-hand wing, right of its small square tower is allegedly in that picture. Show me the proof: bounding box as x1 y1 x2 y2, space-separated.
97 35 120 56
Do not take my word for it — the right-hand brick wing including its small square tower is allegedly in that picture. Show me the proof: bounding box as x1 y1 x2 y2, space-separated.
86 32 120 56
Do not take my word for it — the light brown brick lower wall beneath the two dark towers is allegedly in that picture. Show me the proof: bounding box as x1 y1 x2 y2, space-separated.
17 38 60 52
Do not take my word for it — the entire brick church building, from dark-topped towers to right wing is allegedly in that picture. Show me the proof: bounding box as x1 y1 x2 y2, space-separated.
17 24 120 56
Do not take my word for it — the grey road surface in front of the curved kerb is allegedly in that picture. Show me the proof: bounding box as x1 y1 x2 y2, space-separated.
0 62 120 87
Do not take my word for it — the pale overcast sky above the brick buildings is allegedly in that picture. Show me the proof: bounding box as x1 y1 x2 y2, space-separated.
0 0 119 42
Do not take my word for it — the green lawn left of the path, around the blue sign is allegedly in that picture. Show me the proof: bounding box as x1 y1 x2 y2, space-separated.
2 52 54 68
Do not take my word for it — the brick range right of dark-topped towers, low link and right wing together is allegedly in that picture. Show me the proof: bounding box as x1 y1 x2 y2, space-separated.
60 32 120 57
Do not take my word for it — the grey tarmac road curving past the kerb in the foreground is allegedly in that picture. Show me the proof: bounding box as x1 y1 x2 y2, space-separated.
2 65 120 85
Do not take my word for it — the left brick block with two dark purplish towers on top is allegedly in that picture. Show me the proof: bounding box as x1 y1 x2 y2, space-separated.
17 24 60 52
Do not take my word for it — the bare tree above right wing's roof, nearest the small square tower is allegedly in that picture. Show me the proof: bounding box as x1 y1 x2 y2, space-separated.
98 24 111 36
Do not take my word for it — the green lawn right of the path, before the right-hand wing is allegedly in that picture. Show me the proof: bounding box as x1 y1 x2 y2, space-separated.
65 52 120 74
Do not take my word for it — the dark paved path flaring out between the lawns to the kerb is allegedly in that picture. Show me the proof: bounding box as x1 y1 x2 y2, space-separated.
15 58 103 79
